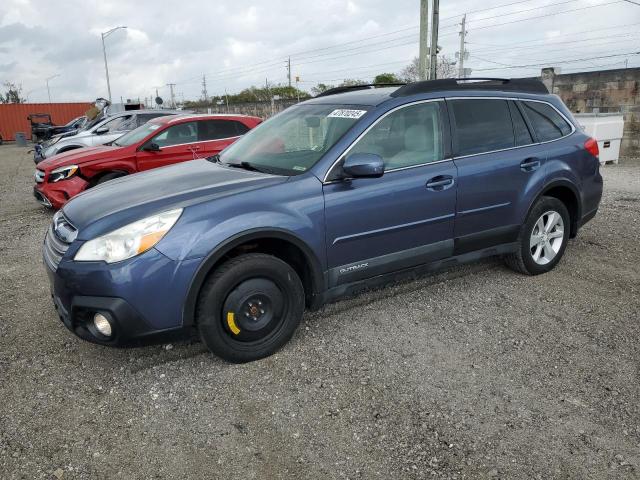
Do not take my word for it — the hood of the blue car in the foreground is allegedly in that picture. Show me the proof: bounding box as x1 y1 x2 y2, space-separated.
63 160 289 240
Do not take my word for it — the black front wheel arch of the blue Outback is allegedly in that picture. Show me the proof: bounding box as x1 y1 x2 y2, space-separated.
182 228 324 326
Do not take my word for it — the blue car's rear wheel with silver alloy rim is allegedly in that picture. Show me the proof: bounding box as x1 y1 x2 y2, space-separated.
505 197 571 275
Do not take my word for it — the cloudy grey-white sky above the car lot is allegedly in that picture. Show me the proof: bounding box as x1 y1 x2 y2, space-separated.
0 0 640 102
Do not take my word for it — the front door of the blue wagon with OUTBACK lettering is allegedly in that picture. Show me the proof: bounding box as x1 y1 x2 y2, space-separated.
324 101 457 286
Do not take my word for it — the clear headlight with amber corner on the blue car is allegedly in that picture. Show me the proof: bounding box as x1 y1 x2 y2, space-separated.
74 208 182 263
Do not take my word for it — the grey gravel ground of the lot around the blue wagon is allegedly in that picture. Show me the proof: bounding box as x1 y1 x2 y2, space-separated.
0 146 640 479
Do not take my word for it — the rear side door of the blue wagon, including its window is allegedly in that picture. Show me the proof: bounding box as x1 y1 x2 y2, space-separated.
447 98 545 254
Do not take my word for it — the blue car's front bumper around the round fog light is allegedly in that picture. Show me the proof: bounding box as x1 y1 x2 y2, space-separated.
45 245 198 346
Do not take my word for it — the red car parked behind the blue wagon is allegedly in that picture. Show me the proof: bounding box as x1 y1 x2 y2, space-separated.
33 115 262 209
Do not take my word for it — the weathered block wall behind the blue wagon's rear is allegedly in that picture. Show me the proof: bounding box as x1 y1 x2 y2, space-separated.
541 68 640 157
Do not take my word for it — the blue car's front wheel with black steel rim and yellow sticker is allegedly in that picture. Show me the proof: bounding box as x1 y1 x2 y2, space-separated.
196 253 304 363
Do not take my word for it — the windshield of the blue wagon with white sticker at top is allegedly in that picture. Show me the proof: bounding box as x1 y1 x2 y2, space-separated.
220 105 369 175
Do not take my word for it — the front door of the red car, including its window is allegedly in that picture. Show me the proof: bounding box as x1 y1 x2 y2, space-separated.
136 121 199 171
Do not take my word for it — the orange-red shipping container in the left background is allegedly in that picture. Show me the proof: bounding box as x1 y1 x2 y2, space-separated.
0 103 93 140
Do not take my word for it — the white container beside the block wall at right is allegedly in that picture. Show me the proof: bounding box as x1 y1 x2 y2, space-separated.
573 113 624 163
